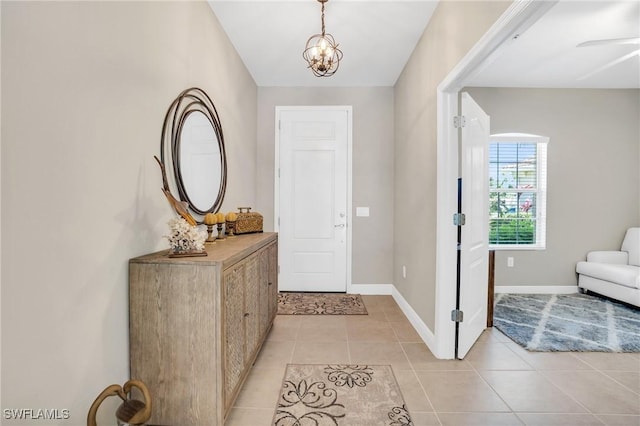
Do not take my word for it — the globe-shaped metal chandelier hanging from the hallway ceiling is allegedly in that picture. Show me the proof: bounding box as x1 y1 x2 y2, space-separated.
302 0 342 77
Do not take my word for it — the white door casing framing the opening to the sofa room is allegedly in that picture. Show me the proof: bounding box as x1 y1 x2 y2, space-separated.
430 1 556 359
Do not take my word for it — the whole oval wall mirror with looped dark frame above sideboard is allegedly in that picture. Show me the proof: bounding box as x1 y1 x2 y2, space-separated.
160 87 227 215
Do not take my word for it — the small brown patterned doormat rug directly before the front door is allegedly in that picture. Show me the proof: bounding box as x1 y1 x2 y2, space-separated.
278 293 367 315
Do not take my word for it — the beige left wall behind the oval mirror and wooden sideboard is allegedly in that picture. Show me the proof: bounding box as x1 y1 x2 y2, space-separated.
1 1 257 425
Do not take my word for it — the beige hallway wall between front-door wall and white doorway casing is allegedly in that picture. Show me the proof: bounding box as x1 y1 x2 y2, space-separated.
393 1 510 331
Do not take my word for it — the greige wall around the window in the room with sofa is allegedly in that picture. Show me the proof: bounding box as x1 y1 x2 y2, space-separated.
467 88 640 286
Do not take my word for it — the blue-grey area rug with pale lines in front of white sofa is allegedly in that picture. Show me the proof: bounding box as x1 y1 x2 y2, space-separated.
493 294 640 352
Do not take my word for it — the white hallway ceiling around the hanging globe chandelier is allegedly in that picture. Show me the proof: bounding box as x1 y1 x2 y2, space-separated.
209 0 437 87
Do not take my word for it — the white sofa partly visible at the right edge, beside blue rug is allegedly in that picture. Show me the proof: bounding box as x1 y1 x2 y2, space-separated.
576 228 640 307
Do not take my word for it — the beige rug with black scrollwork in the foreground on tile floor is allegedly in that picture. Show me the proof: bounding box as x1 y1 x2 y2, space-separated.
273 364 413 426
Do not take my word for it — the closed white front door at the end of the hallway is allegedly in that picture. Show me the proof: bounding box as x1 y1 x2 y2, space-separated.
276 107 351 292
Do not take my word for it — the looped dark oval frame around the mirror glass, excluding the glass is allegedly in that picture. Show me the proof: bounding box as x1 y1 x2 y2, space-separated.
160 87 227 215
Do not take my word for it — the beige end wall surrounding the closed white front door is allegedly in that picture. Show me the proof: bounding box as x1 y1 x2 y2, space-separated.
256 87 393 284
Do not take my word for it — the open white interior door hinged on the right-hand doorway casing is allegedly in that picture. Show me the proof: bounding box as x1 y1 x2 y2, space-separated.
458 92 490 359
